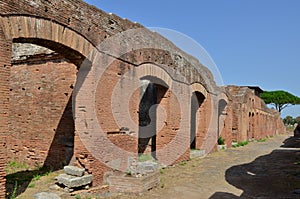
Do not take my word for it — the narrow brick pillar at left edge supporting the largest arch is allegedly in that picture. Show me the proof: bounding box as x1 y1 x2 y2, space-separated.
0 19 12 198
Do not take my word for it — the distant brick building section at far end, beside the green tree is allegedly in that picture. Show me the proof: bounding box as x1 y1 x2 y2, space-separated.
226 86 285 141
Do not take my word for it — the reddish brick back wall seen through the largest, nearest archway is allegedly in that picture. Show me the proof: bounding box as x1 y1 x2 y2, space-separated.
7 46 77 169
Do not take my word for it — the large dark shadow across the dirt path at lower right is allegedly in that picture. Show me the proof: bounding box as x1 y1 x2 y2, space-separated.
210 137 300 199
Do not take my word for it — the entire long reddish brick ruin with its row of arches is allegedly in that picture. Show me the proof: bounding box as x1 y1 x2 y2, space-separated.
0 0 284 198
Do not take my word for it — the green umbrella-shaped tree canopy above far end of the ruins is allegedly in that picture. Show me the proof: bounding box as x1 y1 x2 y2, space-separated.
260 90 300 112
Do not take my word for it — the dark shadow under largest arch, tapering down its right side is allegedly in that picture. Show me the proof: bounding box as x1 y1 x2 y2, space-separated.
8 38 91 170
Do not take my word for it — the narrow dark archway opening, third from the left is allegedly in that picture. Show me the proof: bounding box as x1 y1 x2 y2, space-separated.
190 91 205 149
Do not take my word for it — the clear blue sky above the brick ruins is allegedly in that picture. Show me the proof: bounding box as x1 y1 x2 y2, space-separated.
86 0 300 117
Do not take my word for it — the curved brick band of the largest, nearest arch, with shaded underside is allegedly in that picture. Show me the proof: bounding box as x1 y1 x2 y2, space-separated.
0 15 94 66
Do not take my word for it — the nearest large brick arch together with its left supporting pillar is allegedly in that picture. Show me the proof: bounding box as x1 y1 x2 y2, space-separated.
0 15 93 198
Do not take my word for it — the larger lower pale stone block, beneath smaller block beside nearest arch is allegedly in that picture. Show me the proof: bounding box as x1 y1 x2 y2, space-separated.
56 174 93 188
